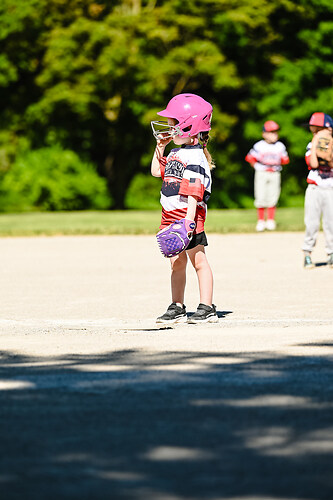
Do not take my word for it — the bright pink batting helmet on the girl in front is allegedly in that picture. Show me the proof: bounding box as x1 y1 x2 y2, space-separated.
157 94 213 137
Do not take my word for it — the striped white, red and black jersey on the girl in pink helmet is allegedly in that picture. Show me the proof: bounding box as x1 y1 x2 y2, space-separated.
160 144 212 233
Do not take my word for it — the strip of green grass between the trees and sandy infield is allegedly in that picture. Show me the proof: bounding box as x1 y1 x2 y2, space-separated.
0 208 304 236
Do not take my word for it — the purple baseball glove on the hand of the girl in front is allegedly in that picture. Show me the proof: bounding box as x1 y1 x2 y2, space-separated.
156 219 196 257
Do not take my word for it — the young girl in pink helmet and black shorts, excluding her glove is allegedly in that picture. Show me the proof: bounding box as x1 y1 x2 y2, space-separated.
151 94 218 323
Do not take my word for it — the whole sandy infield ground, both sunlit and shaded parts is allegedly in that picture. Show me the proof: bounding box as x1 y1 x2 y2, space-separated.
0 233 333 500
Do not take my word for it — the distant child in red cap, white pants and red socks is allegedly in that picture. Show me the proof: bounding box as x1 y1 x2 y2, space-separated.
245 120 289 231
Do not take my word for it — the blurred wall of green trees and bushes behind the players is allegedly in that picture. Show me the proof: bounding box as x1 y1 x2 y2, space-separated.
0 0 333 212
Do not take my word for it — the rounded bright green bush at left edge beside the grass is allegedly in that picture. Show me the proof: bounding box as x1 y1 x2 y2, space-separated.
0 146 111 211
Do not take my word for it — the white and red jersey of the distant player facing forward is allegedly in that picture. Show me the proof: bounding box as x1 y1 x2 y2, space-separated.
245 140 289 172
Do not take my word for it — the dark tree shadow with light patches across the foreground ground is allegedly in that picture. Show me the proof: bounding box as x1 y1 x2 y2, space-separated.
0 340 333 500
